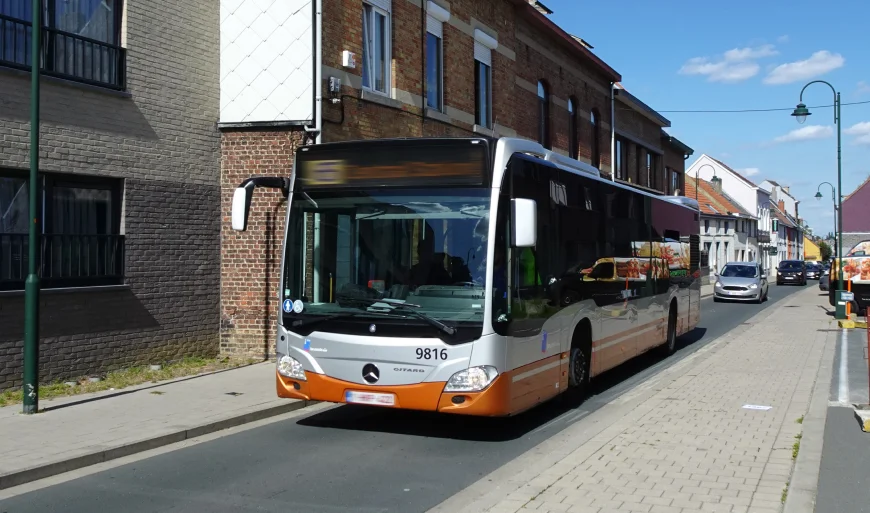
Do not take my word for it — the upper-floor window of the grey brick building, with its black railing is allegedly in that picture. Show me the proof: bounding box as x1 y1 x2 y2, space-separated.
0 0 126 89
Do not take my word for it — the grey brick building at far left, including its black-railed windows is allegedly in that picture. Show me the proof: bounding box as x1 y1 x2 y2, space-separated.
0 0 220 389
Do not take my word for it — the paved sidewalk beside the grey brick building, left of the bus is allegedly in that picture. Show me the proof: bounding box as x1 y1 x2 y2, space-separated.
0 362 306 489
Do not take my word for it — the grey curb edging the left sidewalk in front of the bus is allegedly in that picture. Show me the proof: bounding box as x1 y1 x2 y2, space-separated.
0 401 318 490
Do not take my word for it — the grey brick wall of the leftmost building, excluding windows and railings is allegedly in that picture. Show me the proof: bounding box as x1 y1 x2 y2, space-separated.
0 0 220 389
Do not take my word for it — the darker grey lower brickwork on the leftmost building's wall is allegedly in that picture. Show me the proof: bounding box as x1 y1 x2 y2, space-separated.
0 178 220 389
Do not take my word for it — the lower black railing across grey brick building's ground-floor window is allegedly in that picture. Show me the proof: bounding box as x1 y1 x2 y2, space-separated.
0 233 124 290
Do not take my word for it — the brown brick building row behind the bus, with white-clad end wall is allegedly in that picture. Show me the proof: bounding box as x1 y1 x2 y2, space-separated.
218 0 692 356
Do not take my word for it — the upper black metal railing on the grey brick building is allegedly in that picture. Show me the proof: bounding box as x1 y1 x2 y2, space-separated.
0 14 127 91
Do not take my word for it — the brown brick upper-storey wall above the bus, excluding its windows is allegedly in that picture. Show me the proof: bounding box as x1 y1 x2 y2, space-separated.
323 0 610 168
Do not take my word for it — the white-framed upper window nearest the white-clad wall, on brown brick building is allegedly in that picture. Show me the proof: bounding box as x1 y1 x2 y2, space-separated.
362 0 390 94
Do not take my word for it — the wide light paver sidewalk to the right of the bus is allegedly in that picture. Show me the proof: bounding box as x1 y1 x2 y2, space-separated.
430 289 839 513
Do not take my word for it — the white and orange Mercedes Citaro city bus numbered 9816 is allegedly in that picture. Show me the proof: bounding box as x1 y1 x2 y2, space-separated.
231 137 701 416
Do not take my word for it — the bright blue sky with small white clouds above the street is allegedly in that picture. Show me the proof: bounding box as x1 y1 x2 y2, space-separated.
542 0 870 234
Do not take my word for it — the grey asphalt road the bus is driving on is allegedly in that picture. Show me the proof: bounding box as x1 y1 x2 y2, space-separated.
0 283 816 513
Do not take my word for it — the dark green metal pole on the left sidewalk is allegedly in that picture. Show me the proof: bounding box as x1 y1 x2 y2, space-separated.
23 0 42 415
